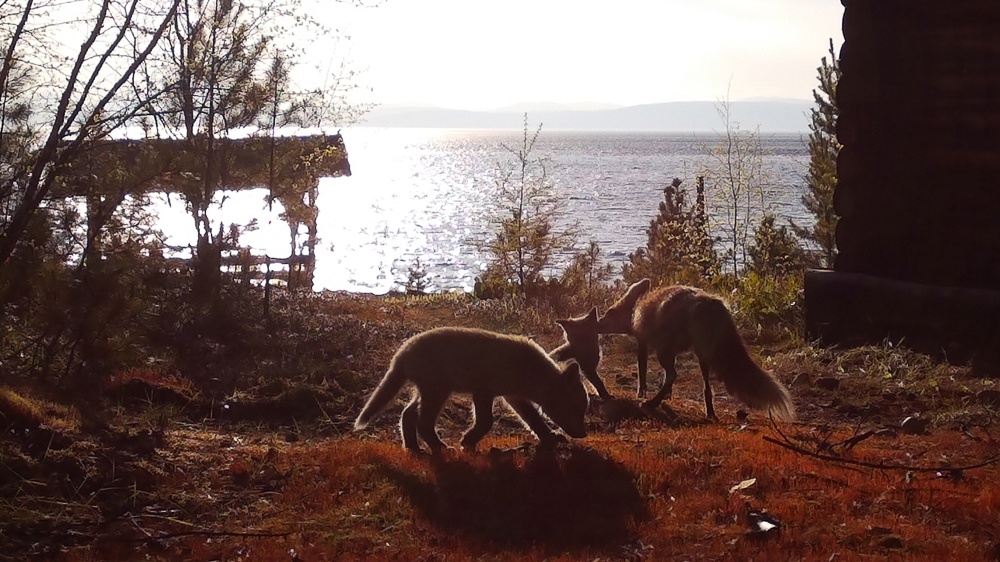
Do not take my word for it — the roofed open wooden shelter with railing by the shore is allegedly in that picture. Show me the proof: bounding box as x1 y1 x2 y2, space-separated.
51 133 351 288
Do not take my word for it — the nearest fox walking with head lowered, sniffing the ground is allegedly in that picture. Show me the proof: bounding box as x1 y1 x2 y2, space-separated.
354 327 590 455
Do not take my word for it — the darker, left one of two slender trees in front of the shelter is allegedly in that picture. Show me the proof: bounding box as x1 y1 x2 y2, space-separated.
150 0 287 302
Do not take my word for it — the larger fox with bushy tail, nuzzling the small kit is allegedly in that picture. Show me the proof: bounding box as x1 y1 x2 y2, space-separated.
597 279 794 420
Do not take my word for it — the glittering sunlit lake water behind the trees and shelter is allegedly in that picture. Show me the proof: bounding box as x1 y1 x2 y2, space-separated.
157 128 813 293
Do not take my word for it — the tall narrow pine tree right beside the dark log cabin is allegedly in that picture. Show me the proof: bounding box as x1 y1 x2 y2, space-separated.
792 39 840 267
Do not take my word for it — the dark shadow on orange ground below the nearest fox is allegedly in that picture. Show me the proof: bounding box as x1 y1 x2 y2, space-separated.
384 447 649 552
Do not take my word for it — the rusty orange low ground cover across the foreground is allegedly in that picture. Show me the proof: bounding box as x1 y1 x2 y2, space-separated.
70 422 1000 560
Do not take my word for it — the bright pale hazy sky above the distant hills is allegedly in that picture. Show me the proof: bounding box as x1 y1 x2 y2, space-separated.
317 0 843 109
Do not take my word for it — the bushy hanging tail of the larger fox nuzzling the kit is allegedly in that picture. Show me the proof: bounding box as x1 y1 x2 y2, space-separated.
691 298 795 421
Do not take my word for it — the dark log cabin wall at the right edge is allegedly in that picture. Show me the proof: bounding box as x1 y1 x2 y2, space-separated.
805 0 1000 365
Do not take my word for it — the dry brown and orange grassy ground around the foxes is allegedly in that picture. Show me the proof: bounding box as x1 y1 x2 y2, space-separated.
0 290 1000 561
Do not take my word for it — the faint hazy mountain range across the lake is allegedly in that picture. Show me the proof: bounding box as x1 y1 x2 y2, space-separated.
360 99 813 132
